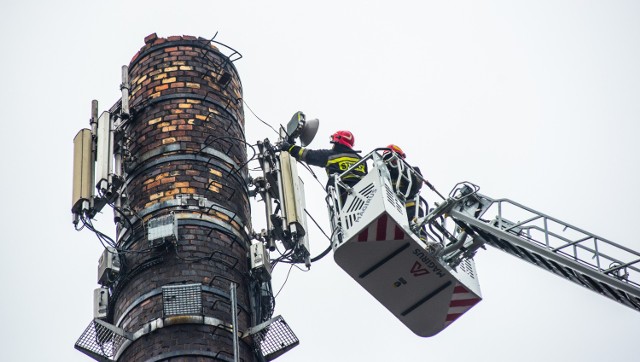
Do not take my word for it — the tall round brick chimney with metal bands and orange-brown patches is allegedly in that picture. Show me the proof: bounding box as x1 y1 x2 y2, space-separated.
109 34 256 361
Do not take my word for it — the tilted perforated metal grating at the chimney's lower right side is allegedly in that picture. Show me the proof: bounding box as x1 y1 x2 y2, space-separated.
253 316 300 361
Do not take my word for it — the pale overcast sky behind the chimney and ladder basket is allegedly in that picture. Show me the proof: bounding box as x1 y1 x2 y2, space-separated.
0 0 640 362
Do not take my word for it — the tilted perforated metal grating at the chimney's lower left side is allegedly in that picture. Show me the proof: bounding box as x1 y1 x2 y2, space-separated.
75 319 127 361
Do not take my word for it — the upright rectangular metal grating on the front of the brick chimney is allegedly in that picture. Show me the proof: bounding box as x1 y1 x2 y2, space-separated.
162 284 202 317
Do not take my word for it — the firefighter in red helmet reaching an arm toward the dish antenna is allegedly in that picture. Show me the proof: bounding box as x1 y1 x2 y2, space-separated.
280 131 367 187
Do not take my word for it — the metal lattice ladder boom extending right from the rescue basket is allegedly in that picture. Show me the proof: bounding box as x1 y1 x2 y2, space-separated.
445 194 640 311
